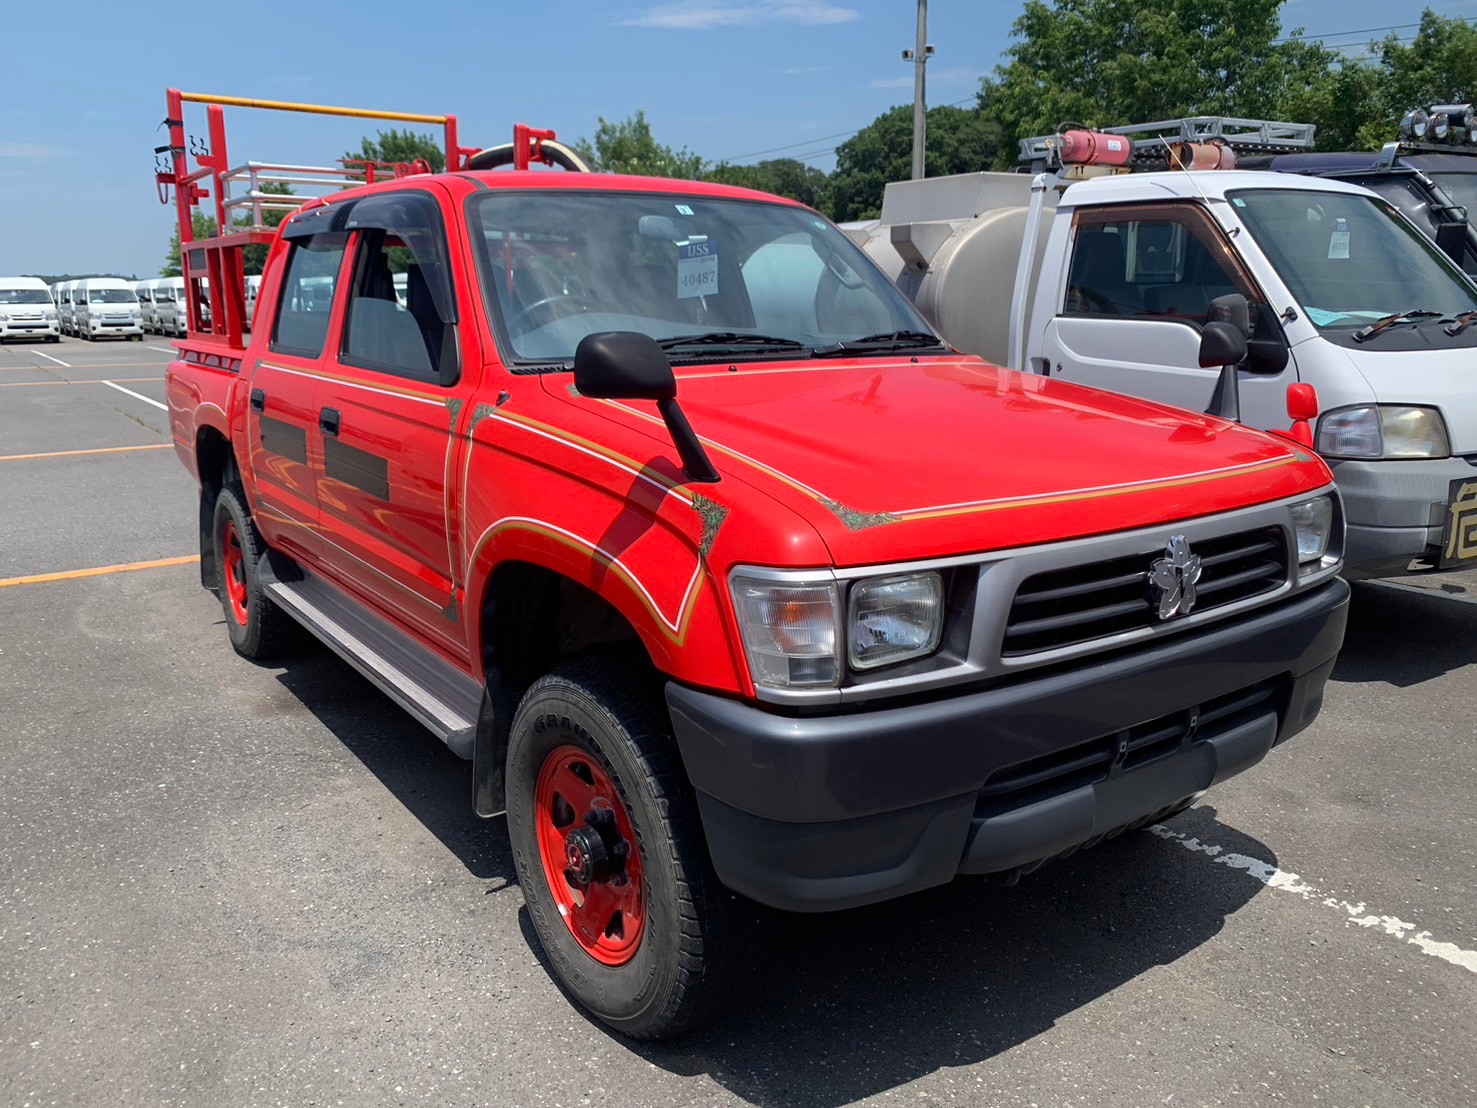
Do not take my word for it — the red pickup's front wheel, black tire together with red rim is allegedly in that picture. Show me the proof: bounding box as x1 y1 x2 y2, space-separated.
507 657 741 1039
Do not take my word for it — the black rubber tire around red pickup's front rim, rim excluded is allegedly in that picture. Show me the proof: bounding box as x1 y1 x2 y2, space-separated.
507 657 752 1039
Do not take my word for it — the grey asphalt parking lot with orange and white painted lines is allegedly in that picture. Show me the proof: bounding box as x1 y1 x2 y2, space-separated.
0 337 1477 1108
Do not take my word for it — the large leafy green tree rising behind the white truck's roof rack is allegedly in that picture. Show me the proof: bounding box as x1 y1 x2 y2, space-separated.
979 0 1335 168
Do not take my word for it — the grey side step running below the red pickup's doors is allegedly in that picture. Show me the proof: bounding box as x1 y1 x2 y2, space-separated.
257 551 482 759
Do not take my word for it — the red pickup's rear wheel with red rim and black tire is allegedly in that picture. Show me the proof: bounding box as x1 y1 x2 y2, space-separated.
211 482 297 662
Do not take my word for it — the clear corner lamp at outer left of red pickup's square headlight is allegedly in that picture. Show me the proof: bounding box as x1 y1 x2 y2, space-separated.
733 576 840 688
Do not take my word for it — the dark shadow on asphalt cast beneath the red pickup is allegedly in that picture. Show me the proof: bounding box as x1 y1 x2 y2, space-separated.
278 647 1276 1108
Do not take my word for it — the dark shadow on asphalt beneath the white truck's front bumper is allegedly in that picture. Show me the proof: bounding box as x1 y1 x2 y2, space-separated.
1332 582 1477 688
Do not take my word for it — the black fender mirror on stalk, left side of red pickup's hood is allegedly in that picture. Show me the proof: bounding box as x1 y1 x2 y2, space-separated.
575 331 719 483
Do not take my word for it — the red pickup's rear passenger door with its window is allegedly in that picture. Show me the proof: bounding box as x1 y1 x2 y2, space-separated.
251 217 349 561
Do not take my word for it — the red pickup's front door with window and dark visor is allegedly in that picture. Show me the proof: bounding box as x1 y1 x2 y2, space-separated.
318 186 474 657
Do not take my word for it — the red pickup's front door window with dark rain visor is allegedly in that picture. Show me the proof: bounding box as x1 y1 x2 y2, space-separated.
341 192 456 383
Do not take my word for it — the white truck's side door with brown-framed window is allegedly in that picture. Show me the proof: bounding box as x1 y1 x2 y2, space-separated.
1040 204 1297 427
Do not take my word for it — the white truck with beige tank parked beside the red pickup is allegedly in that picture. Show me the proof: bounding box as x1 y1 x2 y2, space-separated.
852 117 1477 578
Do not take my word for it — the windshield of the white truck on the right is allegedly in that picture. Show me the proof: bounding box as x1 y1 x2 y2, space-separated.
1226 189 1477 329
